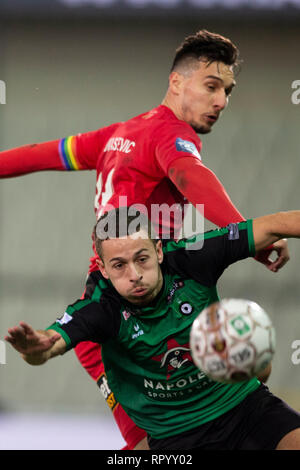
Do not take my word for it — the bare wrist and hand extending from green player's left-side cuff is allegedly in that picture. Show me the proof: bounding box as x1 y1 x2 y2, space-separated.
5 322 66 365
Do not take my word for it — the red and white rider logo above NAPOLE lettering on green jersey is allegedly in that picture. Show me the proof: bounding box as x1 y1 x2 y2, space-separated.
152 338 193 380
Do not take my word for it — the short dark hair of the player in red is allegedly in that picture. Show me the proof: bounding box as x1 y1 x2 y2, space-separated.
171 29 240 72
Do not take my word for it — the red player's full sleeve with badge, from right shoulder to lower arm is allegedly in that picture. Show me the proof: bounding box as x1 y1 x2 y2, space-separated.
155 123 245 227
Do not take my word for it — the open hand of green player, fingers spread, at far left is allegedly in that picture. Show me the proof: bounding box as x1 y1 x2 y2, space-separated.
5 322 61 356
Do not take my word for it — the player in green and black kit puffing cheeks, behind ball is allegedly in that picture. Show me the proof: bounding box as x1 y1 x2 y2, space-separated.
6 208 300 450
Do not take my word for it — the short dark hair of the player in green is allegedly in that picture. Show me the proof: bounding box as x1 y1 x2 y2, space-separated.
93 206 158 258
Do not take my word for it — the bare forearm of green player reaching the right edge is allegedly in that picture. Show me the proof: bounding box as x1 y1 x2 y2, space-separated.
253 211 300 251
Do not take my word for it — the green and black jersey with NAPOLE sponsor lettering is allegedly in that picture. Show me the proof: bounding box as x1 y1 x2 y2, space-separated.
49 220 259 439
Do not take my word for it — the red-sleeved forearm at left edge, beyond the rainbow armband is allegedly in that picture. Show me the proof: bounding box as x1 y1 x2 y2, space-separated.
0 140 65 178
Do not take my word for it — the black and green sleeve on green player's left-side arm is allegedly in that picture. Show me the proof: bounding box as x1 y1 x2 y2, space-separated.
47 299 121 350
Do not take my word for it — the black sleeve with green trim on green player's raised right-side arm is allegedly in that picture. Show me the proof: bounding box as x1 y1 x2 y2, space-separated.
164 220 255 287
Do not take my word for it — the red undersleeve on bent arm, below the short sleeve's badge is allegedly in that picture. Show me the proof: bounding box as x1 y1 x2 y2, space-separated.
169 158 245 227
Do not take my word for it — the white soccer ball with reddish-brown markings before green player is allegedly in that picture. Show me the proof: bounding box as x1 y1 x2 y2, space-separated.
190 299 275 383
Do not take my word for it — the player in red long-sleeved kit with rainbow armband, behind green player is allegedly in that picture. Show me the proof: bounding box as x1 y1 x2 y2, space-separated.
0 31 289 449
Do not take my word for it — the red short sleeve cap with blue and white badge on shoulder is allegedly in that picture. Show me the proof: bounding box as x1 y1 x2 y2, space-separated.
155 124 202 176
